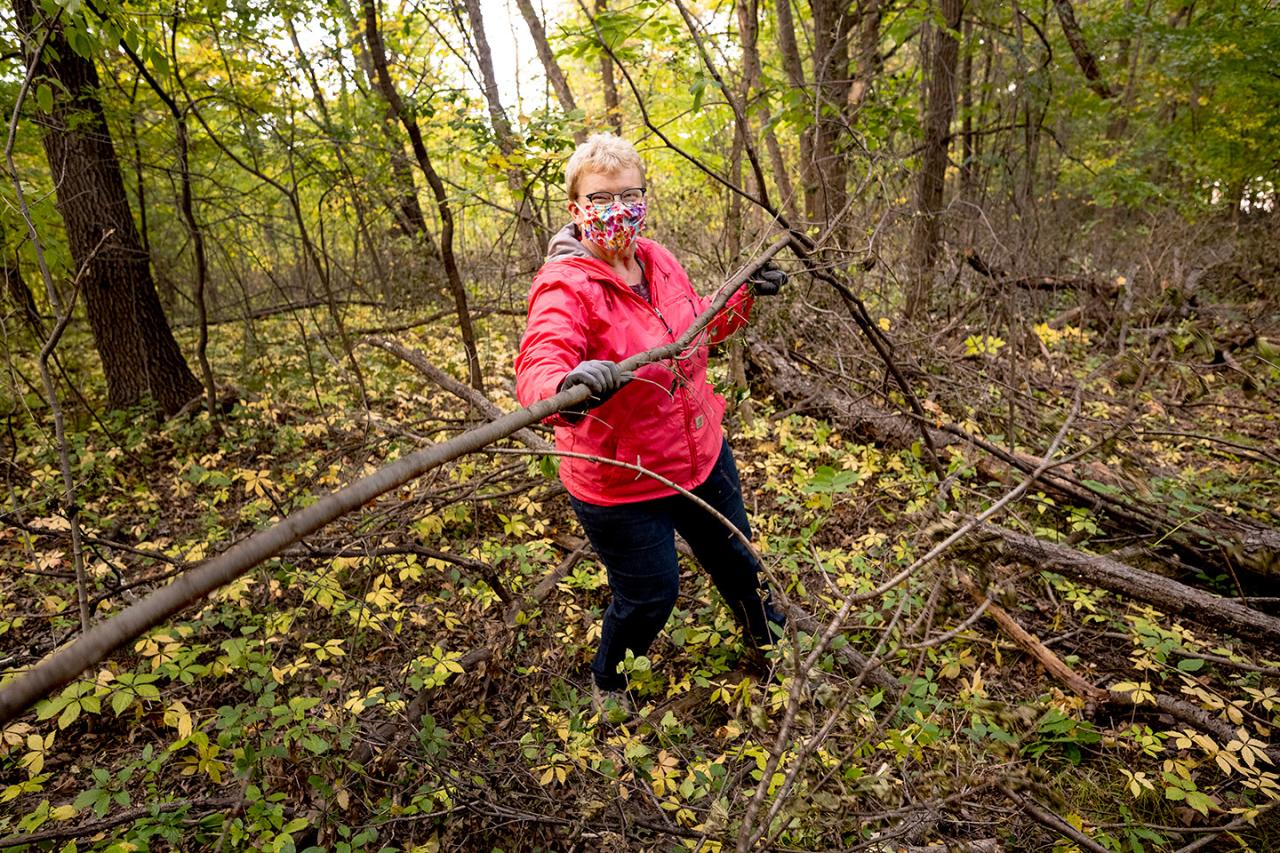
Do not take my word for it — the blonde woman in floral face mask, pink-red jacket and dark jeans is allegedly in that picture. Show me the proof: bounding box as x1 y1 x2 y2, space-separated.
516 133 786 722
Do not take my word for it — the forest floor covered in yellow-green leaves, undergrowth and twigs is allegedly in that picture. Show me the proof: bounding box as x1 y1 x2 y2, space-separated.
0 234 1280 850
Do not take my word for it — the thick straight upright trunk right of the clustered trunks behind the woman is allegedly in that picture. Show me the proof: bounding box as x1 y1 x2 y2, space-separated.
906 0 964 318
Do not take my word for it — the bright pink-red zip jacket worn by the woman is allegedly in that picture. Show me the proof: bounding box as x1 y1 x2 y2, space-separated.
516 224 751 505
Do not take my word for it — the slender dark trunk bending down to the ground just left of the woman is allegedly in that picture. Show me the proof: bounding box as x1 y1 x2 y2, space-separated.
361 0 484 391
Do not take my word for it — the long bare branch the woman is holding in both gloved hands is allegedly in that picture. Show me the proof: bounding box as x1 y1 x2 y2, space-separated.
0 236 791 726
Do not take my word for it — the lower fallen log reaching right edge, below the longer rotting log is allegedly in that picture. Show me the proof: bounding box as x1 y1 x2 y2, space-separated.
974 524 1280 647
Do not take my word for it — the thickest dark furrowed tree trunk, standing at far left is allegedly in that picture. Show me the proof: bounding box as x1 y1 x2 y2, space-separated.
13 0 201 415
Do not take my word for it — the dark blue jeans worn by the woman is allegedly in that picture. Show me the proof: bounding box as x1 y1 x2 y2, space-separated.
570 442 785 690
